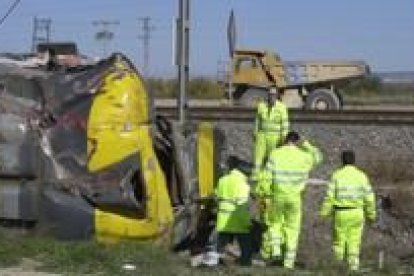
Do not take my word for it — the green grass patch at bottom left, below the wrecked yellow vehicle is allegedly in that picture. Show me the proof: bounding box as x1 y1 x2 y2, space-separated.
0 233 188 275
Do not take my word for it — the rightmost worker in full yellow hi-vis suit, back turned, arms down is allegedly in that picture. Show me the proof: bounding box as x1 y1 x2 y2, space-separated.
321 151 376 271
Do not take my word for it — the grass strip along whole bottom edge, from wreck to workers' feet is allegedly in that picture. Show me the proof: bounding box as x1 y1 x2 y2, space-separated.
0 232 412 276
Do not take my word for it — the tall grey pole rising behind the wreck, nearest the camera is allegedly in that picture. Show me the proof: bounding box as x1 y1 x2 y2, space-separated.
177 0 190 124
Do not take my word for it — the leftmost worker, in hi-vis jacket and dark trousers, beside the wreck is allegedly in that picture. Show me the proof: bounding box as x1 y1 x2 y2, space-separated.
215 156 252 266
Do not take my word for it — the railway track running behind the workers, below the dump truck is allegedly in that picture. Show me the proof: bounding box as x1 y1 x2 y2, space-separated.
156 106 414 125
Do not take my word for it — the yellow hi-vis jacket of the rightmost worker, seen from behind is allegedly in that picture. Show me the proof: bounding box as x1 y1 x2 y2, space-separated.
321 165 376 221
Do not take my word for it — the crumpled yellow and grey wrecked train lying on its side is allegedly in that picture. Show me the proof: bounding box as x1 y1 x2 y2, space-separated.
0 54 222 244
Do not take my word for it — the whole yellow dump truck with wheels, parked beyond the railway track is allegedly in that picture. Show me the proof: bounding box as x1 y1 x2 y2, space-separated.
228 50 369 110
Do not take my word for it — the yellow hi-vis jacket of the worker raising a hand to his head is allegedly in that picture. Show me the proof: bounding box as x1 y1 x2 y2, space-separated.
266 141 322 196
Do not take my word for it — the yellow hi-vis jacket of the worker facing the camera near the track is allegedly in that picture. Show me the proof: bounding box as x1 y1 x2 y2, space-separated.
254 100 289 139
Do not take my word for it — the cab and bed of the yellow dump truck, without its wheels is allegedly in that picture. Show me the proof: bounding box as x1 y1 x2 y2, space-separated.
231 50 369 88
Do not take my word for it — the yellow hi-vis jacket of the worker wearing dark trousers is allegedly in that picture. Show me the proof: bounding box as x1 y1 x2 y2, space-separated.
215 169 251 233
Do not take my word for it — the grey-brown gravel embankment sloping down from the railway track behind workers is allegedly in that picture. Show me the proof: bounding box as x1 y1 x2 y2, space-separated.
216 122 414 269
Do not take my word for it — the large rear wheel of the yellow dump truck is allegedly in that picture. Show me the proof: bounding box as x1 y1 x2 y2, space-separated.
305 89 342 110
